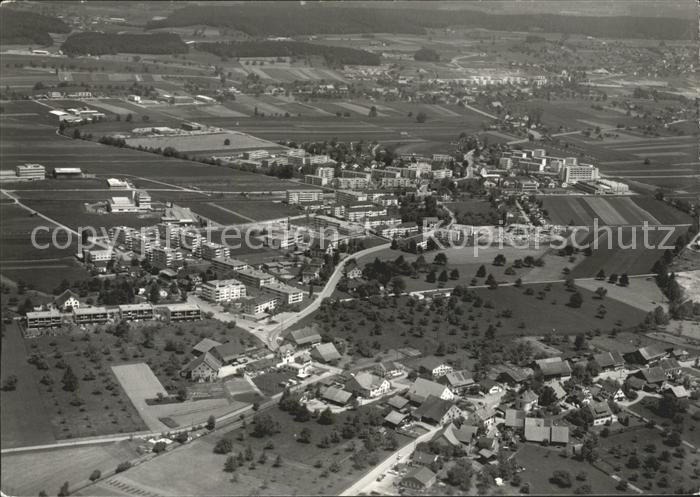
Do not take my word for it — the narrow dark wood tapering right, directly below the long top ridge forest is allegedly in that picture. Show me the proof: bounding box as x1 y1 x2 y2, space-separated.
197 41 380 66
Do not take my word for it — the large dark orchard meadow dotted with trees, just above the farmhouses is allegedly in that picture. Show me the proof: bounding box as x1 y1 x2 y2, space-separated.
290 283 646 359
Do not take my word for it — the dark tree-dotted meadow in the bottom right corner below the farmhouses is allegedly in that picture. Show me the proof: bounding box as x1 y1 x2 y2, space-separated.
599 428 700 494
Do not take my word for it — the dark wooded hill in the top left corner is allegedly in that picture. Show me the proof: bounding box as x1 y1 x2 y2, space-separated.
0 7 70 46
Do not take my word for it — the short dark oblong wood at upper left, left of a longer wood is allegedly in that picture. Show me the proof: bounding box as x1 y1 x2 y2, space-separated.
61 32 188 55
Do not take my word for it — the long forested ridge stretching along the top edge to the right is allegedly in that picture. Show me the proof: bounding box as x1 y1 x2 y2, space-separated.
146 2 698 40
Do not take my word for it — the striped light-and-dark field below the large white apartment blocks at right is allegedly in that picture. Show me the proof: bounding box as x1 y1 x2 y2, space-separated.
540 195 689 226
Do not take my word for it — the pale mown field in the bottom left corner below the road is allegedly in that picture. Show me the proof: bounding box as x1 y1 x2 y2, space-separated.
1 441 138 495
